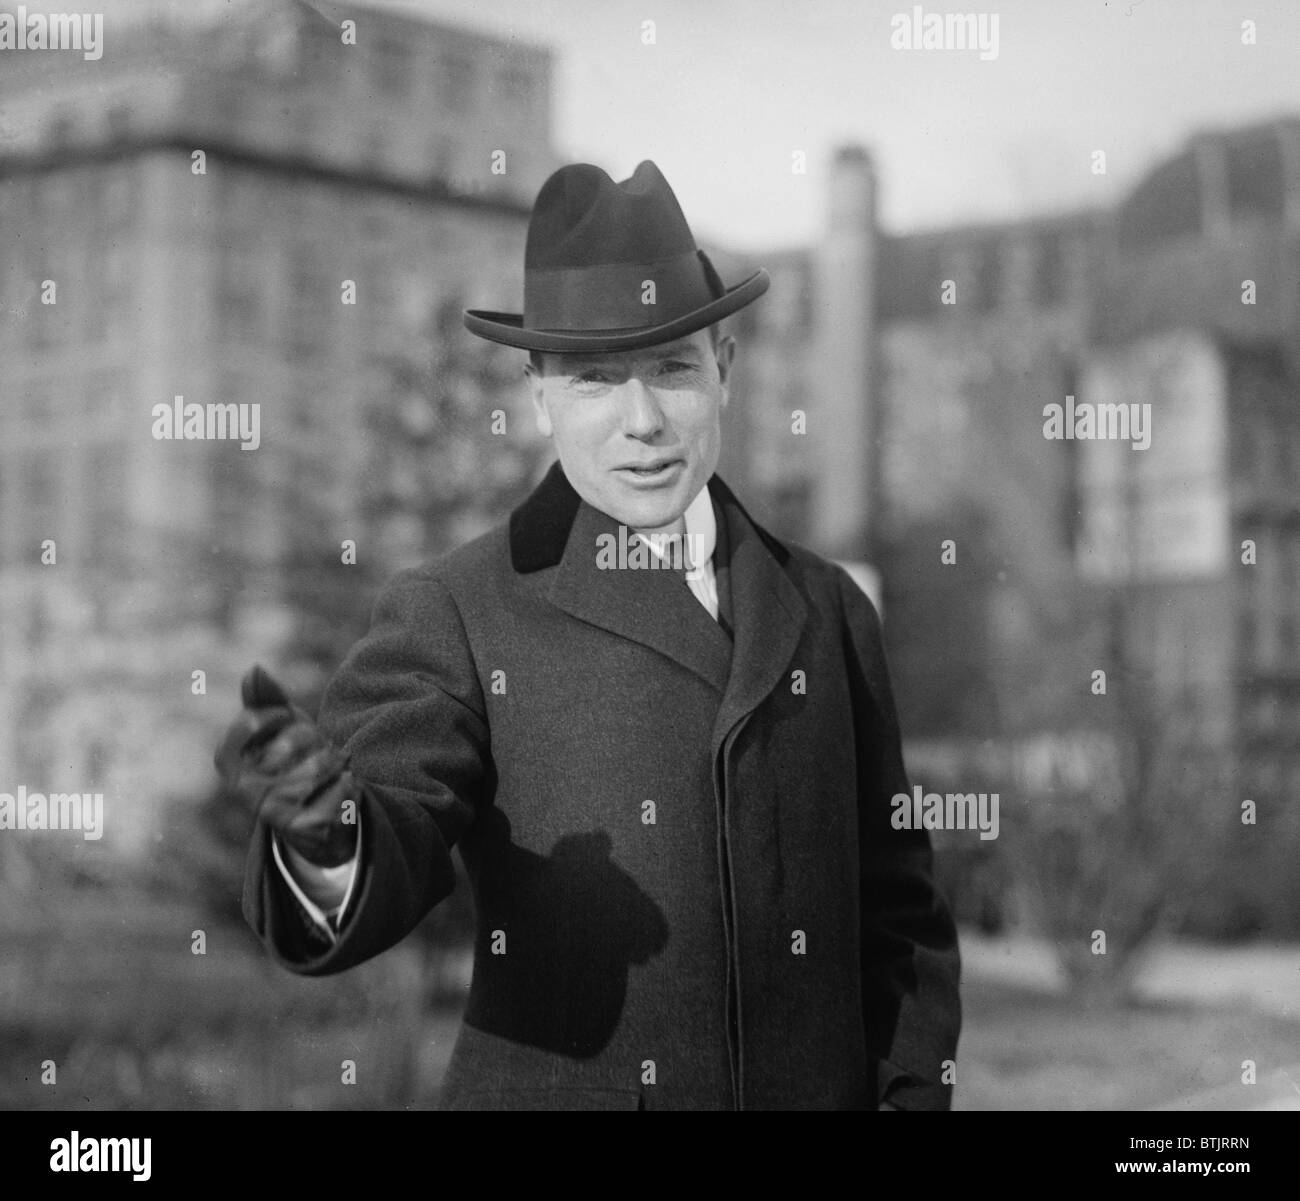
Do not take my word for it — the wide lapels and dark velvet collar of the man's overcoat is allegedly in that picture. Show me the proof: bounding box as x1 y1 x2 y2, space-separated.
510 463 807 746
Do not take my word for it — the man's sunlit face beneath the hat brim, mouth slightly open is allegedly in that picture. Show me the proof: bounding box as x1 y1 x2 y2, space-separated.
527 330 736 530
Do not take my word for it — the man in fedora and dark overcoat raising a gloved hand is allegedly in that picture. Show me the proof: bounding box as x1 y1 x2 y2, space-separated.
218 162 959 1110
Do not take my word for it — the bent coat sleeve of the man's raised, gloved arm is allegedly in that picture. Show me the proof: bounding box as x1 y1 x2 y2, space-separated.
243 568 490 976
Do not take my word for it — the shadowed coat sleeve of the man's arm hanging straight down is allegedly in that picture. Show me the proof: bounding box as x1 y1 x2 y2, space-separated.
840 569 961 1109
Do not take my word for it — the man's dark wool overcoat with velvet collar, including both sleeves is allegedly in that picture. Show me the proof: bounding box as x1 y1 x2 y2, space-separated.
244 464 959 1110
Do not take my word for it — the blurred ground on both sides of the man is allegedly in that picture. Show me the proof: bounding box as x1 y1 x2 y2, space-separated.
0 899 1300 1110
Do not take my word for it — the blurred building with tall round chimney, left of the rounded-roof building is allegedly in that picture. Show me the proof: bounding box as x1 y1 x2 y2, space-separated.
724 147 1105 737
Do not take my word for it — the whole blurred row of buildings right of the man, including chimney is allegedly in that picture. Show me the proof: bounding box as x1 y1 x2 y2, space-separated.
732 120 1300 799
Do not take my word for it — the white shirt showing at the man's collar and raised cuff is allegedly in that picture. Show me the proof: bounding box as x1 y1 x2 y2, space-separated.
270 485 718 942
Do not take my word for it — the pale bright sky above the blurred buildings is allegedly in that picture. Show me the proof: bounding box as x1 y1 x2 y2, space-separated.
369 0 1300 250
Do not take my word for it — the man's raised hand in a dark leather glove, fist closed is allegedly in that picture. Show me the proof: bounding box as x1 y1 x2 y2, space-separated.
215 667 358 867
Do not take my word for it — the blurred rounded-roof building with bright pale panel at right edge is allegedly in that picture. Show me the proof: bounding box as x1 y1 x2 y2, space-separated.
1080 118 1300 805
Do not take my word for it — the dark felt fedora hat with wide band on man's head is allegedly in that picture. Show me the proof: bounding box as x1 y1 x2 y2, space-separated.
465 159 770 354
